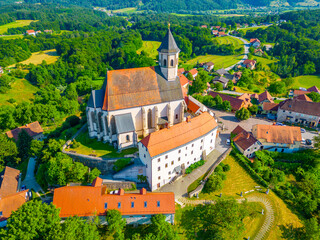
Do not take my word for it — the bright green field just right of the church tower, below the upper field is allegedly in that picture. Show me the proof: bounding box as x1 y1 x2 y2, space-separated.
181 54 243 70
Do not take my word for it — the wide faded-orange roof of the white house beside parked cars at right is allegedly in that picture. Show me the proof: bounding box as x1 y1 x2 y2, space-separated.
252 124 302 144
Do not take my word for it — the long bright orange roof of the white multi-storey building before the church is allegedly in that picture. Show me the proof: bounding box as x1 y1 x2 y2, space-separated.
141 112 218 157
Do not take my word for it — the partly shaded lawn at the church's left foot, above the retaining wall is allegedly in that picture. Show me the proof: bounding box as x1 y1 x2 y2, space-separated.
67 131 138 158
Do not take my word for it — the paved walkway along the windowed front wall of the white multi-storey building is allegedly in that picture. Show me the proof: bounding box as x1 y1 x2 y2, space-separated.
157 150 221 201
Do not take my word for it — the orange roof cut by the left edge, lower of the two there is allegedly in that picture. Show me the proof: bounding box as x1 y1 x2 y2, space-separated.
0 189 29 222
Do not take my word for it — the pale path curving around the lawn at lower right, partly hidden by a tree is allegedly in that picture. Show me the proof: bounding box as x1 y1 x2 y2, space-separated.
178 196 274 240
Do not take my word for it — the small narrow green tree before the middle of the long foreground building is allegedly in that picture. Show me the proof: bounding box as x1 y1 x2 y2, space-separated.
106 210 126 240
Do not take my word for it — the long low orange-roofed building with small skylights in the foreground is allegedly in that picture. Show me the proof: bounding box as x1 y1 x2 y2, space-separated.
52 178 175 224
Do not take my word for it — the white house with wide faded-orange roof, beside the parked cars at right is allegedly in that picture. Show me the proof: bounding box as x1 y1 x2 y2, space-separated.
252 124 302 153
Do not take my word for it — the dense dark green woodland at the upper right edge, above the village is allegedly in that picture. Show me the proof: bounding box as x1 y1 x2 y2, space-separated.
245 10 320 78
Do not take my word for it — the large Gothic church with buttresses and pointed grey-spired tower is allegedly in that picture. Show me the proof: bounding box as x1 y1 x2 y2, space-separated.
86 28 186 150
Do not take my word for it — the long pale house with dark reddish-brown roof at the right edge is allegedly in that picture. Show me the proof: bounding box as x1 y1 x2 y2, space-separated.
277 99 320 127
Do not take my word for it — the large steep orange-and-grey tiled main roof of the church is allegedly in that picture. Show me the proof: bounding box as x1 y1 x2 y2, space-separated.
102 66 183 111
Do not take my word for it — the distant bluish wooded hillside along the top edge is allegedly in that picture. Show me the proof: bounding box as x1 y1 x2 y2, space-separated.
18 0 320 12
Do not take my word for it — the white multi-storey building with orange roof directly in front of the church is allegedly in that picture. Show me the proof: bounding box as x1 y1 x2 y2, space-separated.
138 112 218 191
